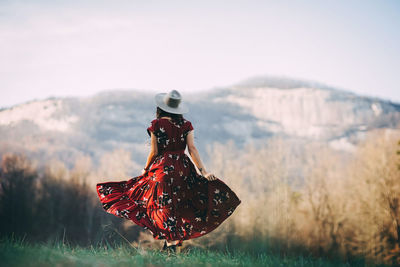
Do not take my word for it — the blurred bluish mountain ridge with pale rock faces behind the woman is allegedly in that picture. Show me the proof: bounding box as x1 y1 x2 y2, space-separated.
0 76 400 171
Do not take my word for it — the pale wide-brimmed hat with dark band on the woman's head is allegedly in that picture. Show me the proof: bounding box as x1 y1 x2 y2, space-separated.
154 90 189 114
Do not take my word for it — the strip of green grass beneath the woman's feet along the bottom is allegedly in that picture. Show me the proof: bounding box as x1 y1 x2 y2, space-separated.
0 238 374 267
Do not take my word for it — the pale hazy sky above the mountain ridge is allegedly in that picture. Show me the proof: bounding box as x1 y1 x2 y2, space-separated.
0 0 400 107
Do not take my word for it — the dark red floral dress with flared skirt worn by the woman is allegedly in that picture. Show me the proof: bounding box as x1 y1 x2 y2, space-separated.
96 118 241 245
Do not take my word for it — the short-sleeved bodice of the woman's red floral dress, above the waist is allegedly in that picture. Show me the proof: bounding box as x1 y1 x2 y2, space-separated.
147 117 193 154
